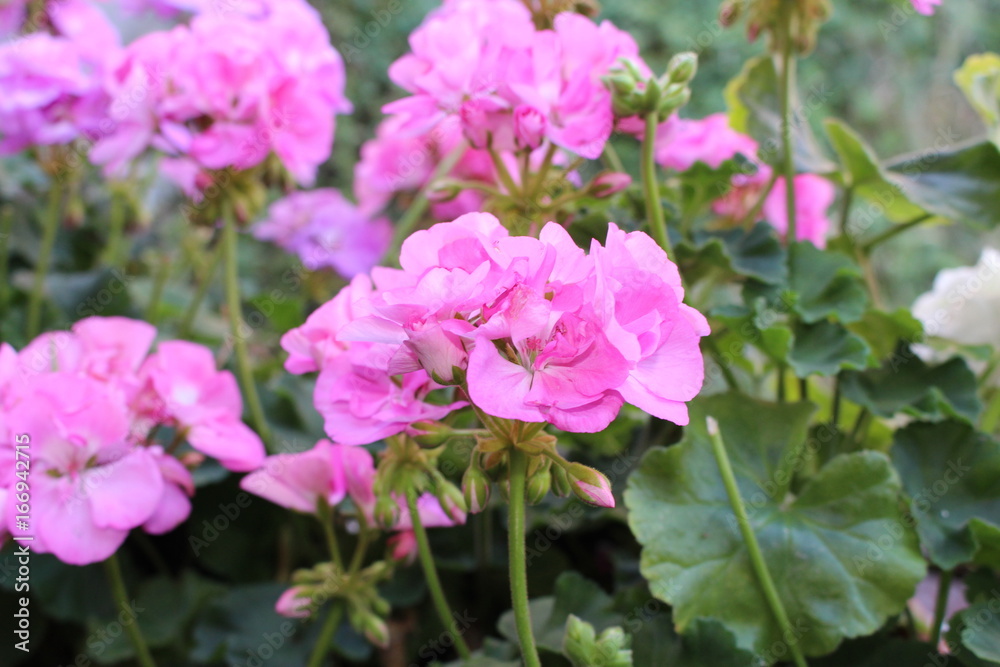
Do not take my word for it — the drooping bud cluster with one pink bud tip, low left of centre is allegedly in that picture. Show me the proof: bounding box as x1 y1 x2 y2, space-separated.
277 561 392 647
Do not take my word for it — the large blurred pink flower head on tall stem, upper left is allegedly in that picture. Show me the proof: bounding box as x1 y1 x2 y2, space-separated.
91 0 351 194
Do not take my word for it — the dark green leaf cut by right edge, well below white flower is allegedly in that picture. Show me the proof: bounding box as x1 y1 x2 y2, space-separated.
892 421 1000 570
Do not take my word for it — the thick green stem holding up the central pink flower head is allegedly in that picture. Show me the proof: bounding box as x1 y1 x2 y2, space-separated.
507 447 542 667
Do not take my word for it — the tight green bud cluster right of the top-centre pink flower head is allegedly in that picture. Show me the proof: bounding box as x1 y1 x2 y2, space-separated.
604 51 698 121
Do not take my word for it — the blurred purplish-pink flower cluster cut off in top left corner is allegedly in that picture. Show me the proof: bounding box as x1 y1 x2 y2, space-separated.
0 0 119 155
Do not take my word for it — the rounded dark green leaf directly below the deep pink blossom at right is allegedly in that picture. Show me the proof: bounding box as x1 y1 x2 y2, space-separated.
787 242 868 324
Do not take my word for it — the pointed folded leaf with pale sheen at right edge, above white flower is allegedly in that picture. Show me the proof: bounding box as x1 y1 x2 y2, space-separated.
886 141 1000 228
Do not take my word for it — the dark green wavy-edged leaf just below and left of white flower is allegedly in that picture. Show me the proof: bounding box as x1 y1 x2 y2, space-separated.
840 346 982 422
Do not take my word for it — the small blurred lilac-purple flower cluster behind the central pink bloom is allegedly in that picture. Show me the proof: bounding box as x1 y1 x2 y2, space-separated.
253 188 392 278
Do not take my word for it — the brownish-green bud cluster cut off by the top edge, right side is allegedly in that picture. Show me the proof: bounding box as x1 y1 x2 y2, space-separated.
719 0 832 54
